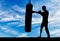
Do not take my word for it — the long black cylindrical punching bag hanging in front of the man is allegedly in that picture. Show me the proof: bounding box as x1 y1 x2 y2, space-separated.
25 0 33 32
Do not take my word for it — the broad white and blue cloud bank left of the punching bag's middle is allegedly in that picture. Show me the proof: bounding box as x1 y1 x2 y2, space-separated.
0 8 25 22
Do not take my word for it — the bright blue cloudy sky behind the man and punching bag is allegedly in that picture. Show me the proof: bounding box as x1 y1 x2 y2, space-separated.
0 0 60 37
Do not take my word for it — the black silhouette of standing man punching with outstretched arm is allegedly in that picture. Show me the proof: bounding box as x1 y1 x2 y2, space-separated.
33 6 50 37
